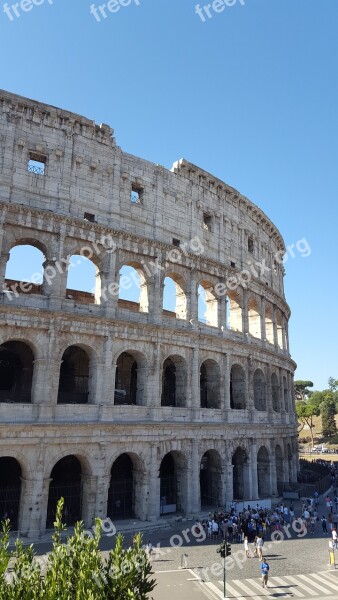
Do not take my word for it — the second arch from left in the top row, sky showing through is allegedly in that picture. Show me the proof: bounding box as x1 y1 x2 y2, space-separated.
66 254 97 304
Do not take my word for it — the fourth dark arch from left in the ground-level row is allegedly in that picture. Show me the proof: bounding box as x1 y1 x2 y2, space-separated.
160 451 187 515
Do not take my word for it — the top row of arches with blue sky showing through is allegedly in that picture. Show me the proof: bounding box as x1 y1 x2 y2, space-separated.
1 240 288 349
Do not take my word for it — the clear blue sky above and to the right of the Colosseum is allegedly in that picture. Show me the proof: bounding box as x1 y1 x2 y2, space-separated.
0 0 338 389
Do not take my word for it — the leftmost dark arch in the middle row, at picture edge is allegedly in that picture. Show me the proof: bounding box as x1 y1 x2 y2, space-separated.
0 341 34 403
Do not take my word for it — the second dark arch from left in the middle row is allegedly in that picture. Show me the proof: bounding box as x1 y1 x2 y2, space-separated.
58 346 90 404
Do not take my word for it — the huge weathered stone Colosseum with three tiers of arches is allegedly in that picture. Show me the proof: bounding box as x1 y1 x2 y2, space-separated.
0 91 298 537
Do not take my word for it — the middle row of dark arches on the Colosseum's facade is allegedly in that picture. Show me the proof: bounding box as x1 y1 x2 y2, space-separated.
0 340 290 412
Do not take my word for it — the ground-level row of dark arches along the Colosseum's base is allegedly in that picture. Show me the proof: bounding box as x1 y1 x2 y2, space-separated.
0 444 292 530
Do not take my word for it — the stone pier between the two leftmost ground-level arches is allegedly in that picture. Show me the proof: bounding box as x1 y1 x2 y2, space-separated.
19 471 51 539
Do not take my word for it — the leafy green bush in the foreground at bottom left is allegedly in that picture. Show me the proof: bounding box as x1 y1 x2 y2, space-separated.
0 499 156 600
